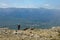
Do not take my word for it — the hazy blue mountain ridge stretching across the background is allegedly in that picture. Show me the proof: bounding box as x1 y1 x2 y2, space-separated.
0 8 60 28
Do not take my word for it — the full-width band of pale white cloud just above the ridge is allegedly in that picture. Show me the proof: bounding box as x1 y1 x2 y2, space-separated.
0 3 60 9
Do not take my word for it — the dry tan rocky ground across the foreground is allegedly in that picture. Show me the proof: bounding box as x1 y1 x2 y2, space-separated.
0 27 60 40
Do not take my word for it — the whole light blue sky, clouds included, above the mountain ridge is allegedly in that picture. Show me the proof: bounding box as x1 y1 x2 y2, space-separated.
0 0 60 9
